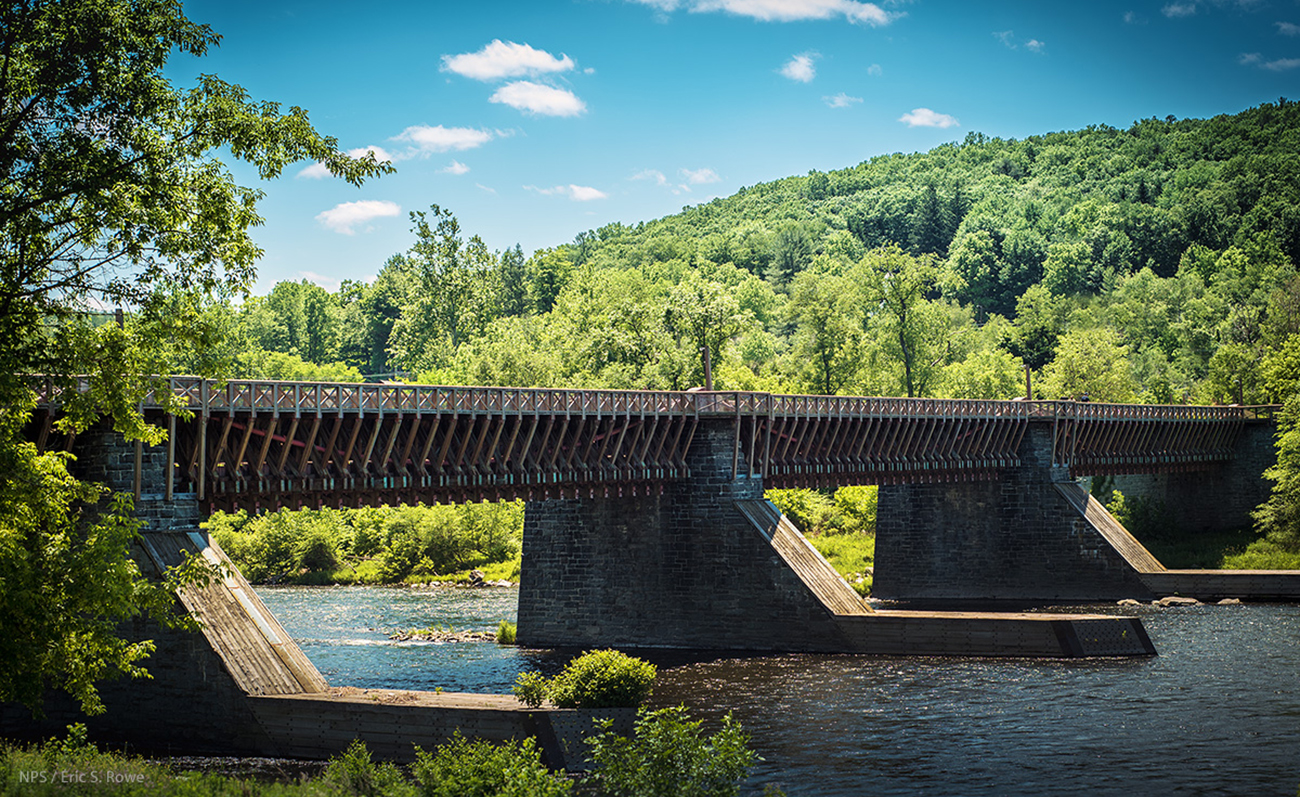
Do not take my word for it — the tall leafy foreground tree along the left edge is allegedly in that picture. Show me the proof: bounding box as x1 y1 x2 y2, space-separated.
0 0 390 711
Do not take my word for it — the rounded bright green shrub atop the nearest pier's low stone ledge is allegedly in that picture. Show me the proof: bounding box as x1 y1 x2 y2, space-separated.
514 650 657 709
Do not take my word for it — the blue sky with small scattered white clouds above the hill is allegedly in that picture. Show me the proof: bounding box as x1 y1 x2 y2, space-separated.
168 0 1300 293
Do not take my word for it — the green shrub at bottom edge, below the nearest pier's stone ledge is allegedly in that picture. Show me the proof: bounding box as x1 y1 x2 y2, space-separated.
411 731 573 797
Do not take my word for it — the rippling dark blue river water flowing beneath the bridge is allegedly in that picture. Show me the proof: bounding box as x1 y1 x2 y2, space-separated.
257 588 1300 797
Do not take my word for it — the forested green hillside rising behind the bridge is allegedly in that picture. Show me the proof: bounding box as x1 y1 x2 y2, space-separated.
159 100 1300 561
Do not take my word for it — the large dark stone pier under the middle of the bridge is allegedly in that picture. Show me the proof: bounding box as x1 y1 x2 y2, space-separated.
517 420 849 651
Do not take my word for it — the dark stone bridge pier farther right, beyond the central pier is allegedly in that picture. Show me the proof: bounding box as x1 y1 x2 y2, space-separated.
871 424 1152 602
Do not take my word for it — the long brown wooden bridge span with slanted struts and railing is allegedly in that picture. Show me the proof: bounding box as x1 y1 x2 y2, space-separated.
25 377 1273 510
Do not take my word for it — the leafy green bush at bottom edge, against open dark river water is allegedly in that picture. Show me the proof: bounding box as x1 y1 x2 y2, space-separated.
586 706 757 797
